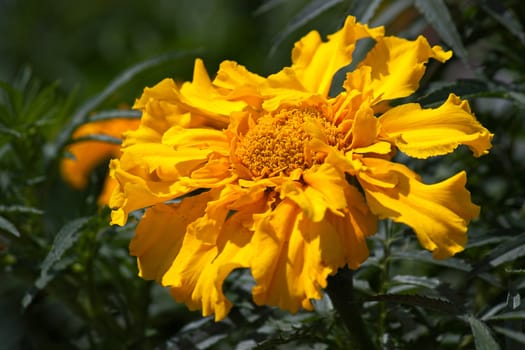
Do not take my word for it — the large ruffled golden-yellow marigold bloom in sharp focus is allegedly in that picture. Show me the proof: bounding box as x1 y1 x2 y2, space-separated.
110 17 492 320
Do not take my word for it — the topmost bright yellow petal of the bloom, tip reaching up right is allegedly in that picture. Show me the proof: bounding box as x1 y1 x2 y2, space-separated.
292 17 384 97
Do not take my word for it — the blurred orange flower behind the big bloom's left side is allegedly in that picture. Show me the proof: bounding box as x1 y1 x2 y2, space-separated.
60 118 139 206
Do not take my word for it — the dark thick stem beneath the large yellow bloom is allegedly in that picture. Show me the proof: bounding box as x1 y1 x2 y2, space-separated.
326 267 376 350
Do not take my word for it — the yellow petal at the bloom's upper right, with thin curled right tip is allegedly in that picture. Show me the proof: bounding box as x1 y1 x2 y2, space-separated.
358 36 452 102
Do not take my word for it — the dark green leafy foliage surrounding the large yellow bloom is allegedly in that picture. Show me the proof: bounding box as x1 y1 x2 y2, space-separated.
0 0 525 349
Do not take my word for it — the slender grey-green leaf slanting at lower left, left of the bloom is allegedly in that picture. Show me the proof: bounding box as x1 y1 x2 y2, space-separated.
22 217 90 309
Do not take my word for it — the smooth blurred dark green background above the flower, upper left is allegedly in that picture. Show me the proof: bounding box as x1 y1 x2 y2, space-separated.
0 0 348 102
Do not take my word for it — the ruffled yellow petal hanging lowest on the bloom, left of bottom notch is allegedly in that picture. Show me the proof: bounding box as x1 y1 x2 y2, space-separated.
162 189 267 321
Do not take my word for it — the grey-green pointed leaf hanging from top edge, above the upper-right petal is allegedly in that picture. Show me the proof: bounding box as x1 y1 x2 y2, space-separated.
414 0 467 61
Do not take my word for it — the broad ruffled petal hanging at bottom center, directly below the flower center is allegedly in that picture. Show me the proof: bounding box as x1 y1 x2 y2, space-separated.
250 199 344 313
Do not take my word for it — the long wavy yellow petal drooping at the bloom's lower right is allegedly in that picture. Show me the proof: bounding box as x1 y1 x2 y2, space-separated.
358 158 479 259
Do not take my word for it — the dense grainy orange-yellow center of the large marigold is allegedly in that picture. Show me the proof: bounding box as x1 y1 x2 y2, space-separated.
235 107 341 177
